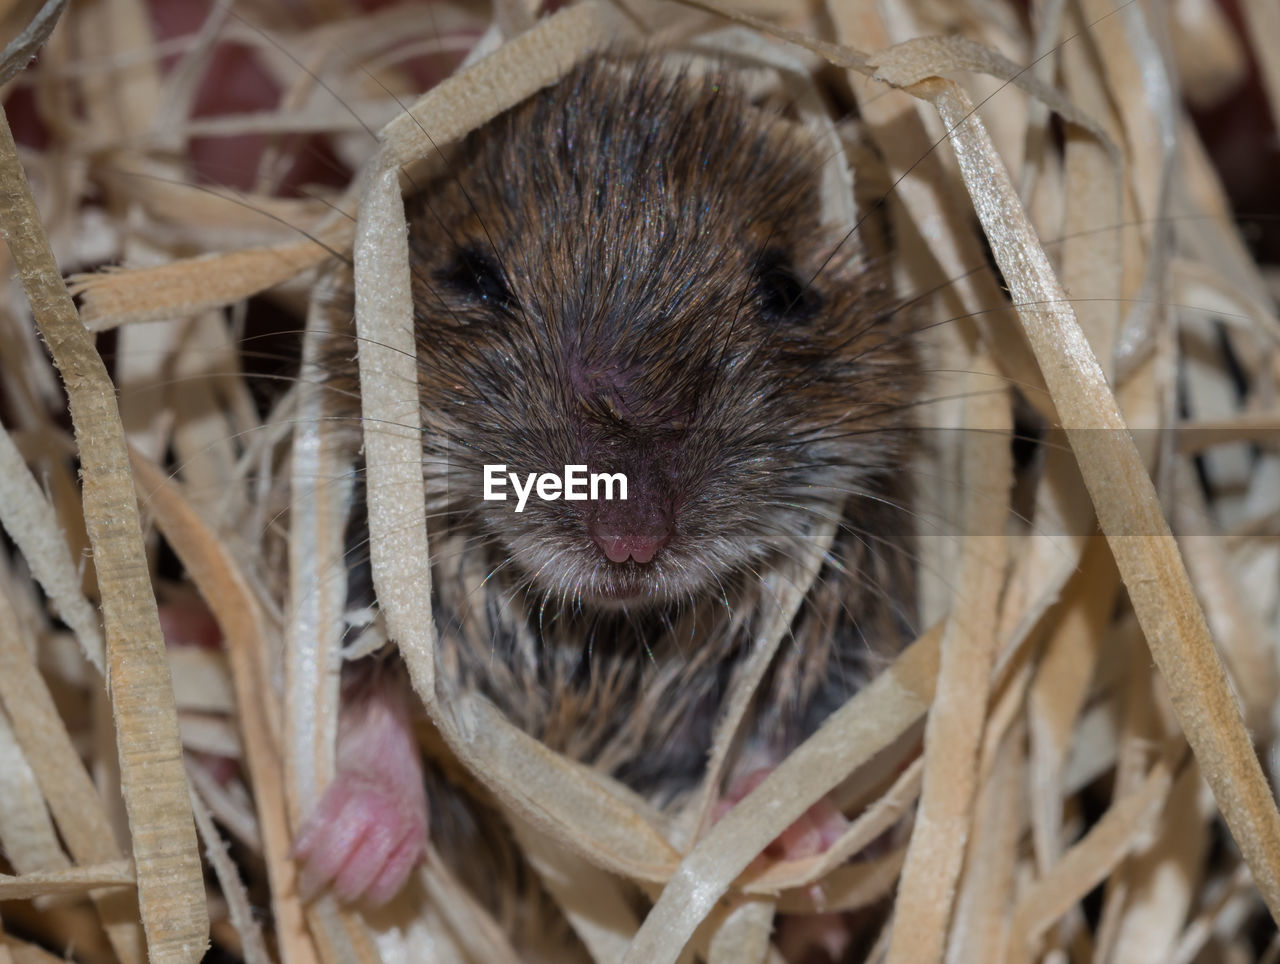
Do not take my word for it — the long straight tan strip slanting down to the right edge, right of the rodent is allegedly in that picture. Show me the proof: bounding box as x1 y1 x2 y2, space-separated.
915 79 1280 920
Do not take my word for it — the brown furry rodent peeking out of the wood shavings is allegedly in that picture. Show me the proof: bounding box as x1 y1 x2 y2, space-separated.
298 51 922 937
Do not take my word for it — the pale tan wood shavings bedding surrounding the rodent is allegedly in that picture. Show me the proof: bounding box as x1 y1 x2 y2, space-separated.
0 0 1280 964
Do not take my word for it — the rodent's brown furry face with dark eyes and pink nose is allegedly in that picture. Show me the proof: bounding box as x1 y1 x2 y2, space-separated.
410 61 916 606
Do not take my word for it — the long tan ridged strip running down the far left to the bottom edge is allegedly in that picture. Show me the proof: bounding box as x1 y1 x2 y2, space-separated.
0 119 209 961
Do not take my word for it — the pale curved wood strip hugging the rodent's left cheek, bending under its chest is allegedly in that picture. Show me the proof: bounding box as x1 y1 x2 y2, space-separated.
355 82 675 896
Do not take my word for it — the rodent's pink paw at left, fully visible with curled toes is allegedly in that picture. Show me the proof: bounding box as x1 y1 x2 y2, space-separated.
293 685 428 904
